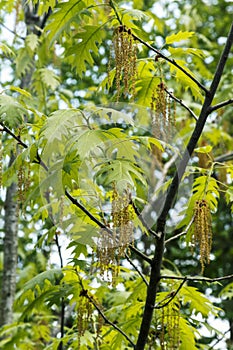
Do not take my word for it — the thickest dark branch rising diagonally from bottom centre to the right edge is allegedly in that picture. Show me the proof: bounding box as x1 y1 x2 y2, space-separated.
136 23 233 350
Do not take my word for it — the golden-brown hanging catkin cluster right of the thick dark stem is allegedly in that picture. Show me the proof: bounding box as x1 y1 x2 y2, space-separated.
192 199 212 273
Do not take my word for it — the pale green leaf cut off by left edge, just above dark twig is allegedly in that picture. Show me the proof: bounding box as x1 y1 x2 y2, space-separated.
0 95 28 128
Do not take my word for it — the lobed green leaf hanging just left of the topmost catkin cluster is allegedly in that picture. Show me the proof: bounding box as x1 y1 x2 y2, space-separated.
67 24 105 76
